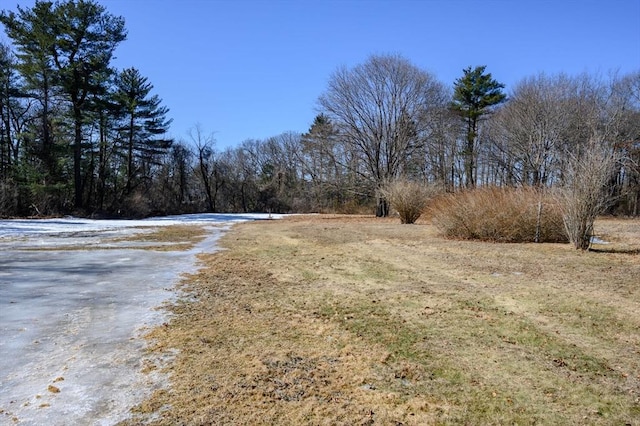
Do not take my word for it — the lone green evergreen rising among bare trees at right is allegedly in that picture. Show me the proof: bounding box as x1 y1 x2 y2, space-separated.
452 65 506 187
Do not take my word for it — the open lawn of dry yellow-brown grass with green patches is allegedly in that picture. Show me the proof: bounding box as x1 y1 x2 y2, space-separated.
124 216 640 425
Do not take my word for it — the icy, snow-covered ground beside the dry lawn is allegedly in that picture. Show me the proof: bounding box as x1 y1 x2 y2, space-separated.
0 214 280 425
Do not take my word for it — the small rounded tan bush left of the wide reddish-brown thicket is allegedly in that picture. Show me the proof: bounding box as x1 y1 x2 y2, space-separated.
380 179 436 224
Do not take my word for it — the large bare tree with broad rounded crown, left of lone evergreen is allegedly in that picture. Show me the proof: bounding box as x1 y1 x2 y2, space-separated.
318 55 444 216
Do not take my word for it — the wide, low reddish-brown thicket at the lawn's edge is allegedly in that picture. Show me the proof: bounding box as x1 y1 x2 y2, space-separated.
429 187 567 243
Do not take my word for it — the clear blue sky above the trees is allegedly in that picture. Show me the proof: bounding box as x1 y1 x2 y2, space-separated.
0 0 640 149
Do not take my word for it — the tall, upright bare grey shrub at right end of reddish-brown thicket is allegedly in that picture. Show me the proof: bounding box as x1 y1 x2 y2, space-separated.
560 139 620 250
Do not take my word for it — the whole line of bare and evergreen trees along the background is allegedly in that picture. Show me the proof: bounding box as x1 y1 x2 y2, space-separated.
0 0 640 216
